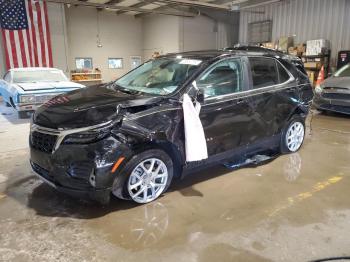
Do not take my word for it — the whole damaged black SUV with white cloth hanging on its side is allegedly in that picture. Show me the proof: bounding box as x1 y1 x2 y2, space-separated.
30 48 313 203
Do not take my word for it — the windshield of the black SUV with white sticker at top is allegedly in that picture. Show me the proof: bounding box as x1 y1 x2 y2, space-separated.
115 58 202 95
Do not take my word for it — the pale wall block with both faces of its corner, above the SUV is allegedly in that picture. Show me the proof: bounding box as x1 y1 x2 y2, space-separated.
142 15 228 59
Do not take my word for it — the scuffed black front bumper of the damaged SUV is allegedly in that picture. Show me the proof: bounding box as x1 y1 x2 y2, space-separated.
30 137 129 203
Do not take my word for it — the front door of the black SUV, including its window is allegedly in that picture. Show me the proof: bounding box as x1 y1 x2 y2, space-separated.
196 58 249 157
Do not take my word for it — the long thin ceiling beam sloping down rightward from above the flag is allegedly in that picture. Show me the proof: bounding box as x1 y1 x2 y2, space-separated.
46 0 195 17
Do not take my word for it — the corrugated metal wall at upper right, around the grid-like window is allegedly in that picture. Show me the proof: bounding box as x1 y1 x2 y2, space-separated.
239 0 350 62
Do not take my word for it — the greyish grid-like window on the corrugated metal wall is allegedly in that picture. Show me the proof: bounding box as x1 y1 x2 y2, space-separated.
248 20 272 44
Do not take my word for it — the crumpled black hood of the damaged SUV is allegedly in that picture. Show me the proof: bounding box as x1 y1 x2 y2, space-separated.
33 85 161 129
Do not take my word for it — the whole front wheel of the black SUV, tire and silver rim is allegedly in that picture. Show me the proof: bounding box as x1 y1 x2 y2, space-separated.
112 149 174 204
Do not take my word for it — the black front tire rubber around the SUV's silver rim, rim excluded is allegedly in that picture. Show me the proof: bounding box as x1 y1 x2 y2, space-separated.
112 149 174 204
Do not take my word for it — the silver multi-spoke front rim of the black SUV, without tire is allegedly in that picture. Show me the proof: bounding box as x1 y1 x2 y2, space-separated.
127 158 168 204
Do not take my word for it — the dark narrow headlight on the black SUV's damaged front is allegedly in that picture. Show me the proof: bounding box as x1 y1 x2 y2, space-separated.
63 127 111 144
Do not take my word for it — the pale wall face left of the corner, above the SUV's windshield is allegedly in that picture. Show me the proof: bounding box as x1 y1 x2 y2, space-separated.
142 15 180 60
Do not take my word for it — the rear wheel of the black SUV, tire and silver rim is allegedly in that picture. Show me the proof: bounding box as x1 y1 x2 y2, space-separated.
281 116 305 153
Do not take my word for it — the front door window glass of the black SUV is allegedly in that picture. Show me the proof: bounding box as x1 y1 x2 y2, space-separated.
197 59 243 97
